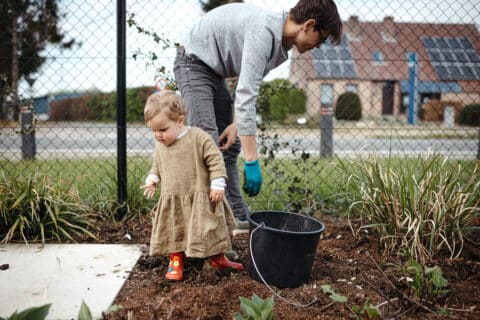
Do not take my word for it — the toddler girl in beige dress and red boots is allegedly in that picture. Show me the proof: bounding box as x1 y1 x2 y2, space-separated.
141 90 243 280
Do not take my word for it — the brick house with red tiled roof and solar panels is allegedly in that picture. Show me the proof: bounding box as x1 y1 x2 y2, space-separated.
289 16 480 116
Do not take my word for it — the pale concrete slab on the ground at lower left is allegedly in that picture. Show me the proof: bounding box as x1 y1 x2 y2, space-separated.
0 244 141 320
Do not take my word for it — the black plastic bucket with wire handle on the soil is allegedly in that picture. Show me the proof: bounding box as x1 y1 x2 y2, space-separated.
248 211 325 288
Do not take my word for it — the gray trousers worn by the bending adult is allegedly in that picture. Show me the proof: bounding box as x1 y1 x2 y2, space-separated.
173 47 249 219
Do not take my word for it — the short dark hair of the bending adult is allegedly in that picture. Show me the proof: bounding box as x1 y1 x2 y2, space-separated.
290 0 342 44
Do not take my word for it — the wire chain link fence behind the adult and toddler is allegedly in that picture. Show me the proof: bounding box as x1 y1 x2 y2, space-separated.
0 0 480 215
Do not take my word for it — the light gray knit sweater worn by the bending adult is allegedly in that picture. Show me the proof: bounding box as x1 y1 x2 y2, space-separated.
183 3 290 135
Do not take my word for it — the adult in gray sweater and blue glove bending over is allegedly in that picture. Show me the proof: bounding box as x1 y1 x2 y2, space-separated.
174 0 342 227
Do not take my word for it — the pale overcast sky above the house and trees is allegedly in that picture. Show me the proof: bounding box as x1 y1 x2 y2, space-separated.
20 0 480 96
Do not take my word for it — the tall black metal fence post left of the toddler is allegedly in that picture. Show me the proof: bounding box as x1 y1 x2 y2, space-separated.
117 0 127 219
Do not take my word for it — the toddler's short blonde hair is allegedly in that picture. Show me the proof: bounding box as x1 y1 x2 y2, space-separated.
143 90 187 122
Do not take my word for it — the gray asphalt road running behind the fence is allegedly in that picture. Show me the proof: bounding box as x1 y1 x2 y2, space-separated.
0 123 479 159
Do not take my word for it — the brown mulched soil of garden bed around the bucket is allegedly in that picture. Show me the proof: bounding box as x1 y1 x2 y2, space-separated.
94 216 480 320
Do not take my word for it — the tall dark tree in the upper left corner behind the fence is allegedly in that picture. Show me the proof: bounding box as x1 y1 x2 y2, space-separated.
0 0 75 119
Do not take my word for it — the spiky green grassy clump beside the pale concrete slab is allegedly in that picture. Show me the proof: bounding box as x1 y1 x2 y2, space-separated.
0 174 95 243
